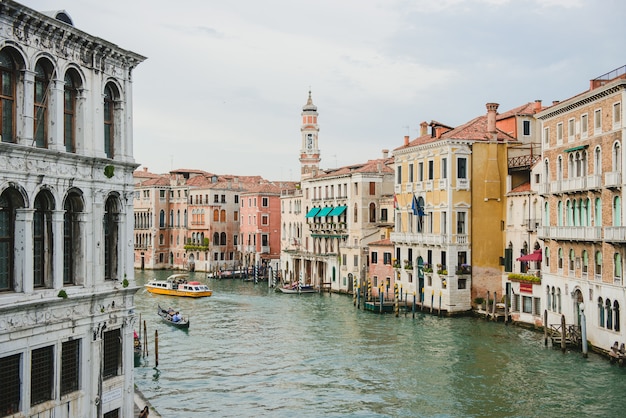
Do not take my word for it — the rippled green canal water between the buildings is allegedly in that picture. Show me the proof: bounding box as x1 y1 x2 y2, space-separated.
135 271 626 418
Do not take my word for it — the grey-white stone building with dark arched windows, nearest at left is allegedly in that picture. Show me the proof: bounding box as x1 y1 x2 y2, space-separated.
0 0 145 418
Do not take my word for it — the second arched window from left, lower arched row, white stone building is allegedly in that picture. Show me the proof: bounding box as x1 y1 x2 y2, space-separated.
33 190 54 287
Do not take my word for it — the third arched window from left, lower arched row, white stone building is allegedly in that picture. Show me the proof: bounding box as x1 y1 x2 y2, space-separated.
63 192 83 285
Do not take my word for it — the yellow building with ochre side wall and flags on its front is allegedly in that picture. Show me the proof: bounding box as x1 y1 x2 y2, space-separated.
391 103 515 313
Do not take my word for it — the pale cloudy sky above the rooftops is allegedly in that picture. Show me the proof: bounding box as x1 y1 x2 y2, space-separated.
19 0 626 181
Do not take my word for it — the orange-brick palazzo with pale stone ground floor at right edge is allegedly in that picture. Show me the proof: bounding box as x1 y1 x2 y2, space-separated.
537 67 626 350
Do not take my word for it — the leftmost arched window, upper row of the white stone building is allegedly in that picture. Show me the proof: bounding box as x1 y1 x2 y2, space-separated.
0 49 18 142
